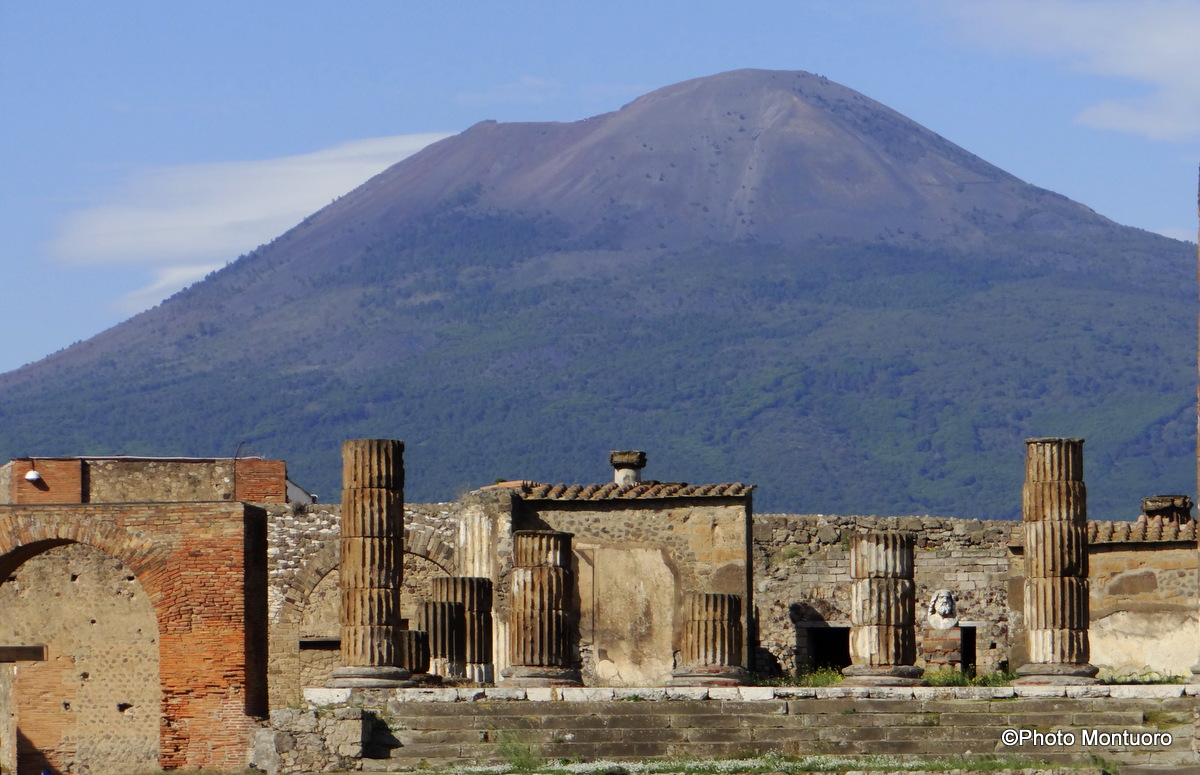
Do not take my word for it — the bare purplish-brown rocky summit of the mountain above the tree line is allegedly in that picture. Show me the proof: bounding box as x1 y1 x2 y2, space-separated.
307 70 1097 250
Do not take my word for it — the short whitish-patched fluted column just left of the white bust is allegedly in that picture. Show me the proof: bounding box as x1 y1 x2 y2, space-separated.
842 530 924 686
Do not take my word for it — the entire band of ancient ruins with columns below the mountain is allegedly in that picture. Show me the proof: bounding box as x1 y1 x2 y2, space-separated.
0 439 1200 775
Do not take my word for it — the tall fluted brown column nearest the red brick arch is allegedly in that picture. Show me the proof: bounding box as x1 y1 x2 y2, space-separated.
330 439 412 687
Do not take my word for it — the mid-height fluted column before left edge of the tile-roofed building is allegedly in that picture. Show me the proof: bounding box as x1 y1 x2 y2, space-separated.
503 530 581 686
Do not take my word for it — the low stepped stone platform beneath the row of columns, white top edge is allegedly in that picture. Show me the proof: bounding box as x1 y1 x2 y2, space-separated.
253 685 1200 775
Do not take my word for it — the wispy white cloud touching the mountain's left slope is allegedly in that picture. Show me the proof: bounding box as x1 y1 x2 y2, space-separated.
49 133 448 312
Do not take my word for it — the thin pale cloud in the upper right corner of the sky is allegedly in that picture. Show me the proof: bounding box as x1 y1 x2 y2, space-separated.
936 0 1200 140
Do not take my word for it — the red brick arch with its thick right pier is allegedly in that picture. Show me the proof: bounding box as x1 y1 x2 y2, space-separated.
0 503 266 769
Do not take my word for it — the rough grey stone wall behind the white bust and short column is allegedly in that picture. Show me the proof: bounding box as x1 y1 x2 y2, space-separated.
754 515 1021 672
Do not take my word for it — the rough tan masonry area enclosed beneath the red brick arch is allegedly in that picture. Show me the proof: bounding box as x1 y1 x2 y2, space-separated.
0 543 162 775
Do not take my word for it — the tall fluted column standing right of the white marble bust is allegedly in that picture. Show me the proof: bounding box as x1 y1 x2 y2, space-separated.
1016 439 1097 684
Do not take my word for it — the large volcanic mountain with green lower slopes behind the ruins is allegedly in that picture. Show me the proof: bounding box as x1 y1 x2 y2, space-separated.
0 70 1198 518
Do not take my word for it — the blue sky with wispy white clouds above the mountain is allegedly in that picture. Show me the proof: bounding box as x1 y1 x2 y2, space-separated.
0 0 1200 371
